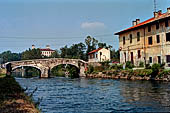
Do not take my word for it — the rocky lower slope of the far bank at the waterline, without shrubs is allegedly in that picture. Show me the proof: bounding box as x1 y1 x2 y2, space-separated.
86 69 170 82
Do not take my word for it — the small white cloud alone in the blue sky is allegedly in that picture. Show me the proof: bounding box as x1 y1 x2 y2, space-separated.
81 22 105 29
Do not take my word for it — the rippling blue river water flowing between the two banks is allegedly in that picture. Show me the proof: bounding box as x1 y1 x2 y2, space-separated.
16 77 170 113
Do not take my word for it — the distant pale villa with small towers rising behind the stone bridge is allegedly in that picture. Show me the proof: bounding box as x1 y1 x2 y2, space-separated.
32 45 55 57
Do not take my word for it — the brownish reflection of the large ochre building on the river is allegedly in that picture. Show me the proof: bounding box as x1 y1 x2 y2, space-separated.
120 81 170 112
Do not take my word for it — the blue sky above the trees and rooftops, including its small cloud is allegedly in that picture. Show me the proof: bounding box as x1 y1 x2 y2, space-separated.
0 0 170 52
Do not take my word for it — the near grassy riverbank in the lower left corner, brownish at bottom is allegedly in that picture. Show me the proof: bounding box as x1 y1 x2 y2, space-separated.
0 77 40 113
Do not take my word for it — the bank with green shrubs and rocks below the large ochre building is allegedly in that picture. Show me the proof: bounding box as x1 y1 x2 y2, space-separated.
85 62 170 81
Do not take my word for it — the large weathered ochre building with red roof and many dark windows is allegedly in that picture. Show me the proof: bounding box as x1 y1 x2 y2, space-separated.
115 8 170 67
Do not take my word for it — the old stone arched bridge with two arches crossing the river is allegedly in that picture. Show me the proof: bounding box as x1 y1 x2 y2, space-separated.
6 58 87 78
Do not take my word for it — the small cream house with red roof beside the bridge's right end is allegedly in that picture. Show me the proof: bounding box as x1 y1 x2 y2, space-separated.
88 48 110 62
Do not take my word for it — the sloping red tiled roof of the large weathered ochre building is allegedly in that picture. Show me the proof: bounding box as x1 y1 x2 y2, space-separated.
115 13 170 35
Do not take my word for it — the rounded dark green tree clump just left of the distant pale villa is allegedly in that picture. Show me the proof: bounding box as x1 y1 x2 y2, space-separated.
21 49 42 60
